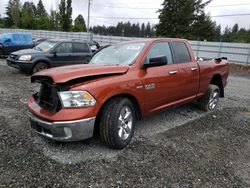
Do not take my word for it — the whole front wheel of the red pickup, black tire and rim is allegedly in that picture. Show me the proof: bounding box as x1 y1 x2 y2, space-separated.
99 97 135 149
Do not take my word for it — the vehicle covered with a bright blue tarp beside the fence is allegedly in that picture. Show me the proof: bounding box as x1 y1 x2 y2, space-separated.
0 33 34 56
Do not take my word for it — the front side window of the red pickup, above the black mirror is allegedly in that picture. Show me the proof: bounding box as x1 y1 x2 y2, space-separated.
147 42 173 64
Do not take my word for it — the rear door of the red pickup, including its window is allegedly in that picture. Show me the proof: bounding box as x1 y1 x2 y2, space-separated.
171 41 199 100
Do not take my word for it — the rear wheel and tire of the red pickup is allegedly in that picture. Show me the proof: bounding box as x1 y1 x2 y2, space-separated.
198 84 220 112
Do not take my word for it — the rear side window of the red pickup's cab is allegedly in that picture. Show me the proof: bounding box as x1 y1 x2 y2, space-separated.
172 42 191 63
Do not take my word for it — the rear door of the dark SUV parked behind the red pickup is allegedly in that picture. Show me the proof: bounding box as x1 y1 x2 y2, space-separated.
73 42 92 64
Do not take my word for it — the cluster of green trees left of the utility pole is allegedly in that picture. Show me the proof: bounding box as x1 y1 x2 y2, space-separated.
0 0 86 32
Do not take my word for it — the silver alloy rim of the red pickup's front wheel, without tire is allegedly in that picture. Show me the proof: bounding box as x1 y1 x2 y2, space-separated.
118 106 133 140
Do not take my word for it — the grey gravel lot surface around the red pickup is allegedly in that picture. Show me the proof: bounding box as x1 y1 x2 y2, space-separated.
0 59 250 187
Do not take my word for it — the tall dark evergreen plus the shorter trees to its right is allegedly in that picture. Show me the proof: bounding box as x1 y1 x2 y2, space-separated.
156 0 250 42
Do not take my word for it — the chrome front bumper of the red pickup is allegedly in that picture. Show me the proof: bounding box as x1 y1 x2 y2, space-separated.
28 113 95 141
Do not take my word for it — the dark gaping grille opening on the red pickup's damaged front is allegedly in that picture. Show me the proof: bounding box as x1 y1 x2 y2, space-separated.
34 84 62 112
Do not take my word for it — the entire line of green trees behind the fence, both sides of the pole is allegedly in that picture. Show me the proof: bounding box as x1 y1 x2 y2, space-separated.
0 0 250 42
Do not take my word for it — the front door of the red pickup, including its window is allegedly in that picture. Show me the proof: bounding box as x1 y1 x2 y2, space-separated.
142 42 179 112
